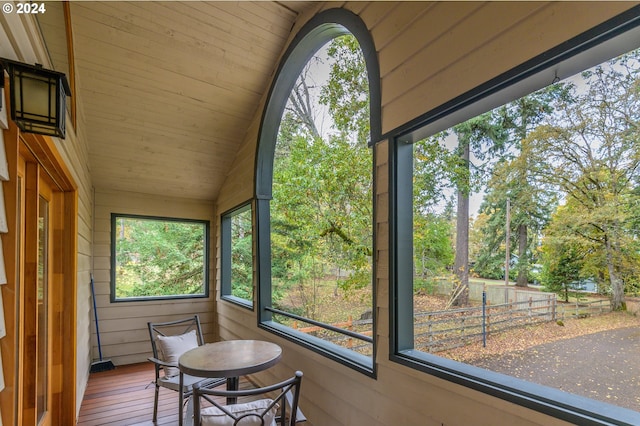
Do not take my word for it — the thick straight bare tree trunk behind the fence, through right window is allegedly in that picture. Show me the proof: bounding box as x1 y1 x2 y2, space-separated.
453 144 469 306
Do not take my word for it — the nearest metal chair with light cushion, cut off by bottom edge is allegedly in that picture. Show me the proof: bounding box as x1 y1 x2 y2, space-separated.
193 371 307 426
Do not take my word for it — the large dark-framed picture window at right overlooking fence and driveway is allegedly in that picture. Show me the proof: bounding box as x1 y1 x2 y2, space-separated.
392 10 640 424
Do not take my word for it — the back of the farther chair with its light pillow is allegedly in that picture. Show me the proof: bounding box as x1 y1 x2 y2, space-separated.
147 315 204 376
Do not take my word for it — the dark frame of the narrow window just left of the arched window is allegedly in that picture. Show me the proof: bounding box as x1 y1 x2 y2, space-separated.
220 201 255 310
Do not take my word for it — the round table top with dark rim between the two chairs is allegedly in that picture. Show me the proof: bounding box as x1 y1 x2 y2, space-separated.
178 340 282 377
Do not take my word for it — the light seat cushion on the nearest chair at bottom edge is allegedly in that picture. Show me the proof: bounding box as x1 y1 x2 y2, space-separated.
200 399 278 426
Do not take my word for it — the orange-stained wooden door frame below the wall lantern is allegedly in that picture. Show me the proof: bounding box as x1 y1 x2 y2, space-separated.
0 111 78 426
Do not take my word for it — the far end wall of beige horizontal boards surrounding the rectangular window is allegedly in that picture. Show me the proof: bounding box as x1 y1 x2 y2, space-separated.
86 190 218 365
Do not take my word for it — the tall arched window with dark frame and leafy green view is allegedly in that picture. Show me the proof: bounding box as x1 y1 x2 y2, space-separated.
256 9 380 373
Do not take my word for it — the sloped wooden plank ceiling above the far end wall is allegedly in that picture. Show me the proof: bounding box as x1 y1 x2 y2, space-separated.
71 1 314 200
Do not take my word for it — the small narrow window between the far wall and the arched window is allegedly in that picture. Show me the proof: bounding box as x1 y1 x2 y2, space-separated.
221 204 253 308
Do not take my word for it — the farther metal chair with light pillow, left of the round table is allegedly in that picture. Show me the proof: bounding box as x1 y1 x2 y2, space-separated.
147 315 226 424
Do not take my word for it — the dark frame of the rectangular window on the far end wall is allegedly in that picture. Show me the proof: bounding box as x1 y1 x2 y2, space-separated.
109 213 211 303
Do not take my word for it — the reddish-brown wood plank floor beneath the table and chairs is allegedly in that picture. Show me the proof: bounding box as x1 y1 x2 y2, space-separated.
77 363 251 426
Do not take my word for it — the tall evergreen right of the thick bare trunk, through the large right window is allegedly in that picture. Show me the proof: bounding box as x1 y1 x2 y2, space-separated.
476 85 565 287
